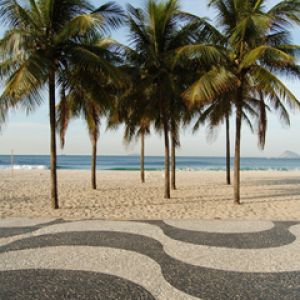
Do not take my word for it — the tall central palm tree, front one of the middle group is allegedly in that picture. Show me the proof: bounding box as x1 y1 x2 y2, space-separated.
127 0 218 198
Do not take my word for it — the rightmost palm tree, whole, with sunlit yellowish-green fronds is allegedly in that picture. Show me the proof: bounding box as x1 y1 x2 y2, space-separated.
185 0 300 204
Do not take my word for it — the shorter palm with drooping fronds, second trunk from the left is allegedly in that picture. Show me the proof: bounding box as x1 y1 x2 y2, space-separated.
57 36 126 190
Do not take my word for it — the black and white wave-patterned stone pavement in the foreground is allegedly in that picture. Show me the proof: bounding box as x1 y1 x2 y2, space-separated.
0 219 300 300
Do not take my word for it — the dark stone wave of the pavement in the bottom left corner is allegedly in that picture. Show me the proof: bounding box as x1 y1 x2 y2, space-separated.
0 270 155 300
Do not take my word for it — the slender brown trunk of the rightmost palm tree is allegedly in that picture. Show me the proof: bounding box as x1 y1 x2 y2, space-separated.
234 105 242 204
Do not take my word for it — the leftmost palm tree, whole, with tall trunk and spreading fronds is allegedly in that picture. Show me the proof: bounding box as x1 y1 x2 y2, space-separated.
0 0 122 209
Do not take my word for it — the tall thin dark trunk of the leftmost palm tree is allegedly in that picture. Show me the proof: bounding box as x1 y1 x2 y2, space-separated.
49 70 59 209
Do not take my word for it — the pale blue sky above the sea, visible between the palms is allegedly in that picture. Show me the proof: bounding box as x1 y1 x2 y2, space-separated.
0 0 300 157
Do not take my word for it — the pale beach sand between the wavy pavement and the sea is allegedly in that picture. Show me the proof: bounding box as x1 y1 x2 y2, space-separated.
0 170 300 220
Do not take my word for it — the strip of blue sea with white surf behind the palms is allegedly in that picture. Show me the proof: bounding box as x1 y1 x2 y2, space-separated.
0 155 300 171
